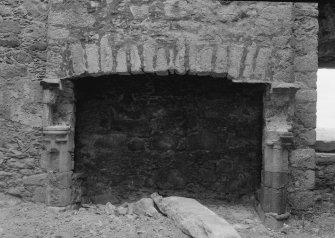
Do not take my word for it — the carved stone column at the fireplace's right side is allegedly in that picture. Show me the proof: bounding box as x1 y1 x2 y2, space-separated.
257 84 296 229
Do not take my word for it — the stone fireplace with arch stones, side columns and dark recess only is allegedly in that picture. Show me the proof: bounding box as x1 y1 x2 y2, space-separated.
42 22 297 227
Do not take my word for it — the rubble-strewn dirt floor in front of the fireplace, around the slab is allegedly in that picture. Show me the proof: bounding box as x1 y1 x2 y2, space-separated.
0 195 335 238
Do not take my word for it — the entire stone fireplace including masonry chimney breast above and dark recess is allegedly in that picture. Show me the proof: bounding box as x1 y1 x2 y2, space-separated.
36 0 317 231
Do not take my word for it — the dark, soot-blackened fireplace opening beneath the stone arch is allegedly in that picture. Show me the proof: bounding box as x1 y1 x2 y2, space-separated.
74 74 265 204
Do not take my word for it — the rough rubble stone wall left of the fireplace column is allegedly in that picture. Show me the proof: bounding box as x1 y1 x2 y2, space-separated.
0 0 48 202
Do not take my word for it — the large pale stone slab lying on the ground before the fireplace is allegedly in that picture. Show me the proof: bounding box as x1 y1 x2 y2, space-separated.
151 194 240 238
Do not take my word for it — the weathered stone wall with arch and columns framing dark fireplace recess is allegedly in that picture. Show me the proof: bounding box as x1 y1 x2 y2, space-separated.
0 0 318 228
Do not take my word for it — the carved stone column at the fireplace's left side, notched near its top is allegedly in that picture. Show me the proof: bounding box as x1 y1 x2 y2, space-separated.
41 80 74 207
